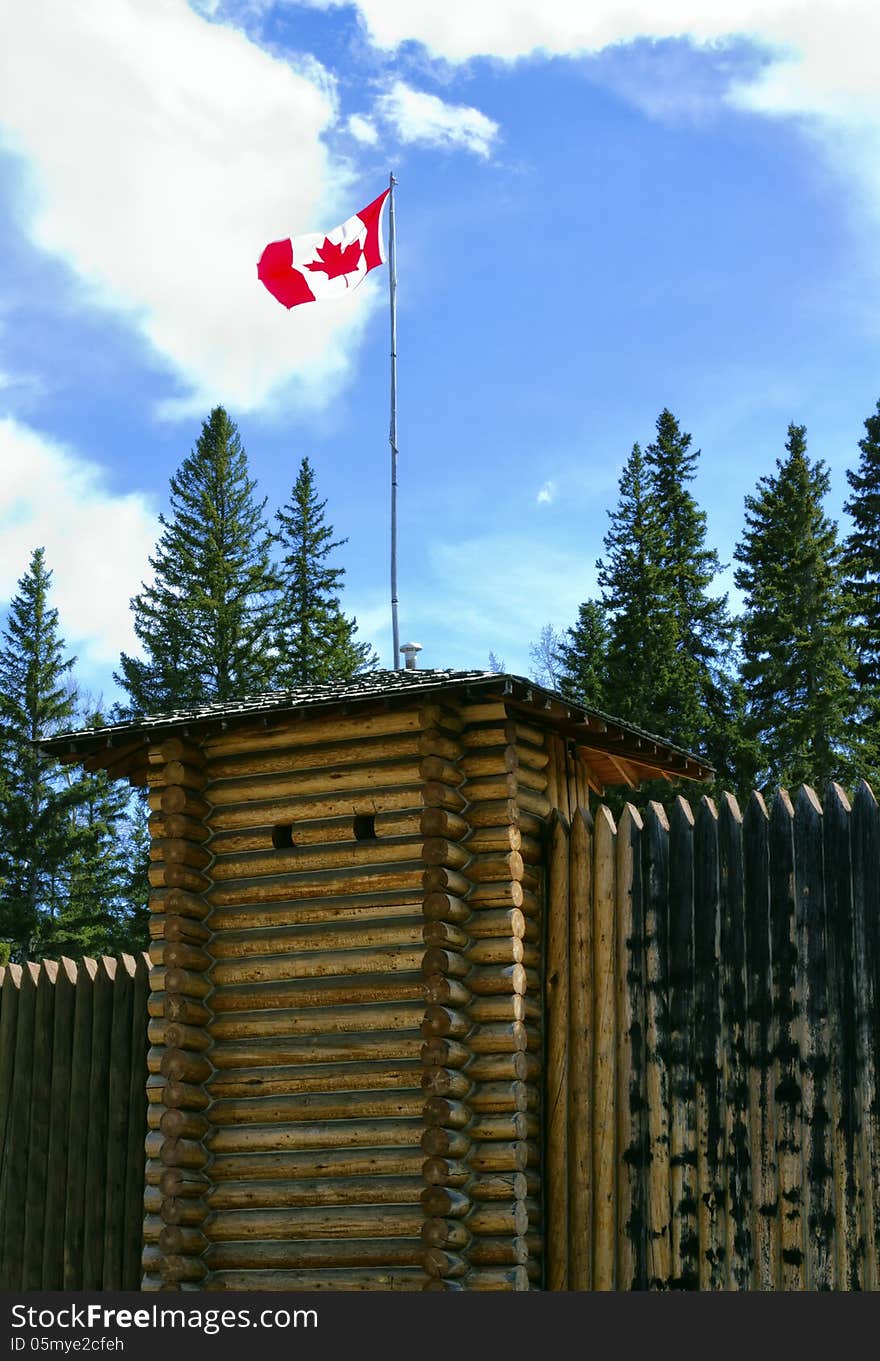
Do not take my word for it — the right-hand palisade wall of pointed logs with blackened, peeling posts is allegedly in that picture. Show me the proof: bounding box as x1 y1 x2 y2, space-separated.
554 785 880 1290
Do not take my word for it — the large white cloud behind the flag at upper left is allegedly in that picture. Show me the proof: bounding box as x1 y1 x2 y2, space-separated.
0 0 375 411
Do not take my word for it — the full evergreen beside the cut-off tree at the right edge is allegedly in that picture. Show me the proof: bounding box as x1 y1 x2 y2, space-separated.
734 425 854 785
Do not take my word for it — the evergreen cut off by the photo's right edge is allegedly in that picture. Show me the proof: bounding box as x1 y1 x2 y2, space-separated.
843 401 880 781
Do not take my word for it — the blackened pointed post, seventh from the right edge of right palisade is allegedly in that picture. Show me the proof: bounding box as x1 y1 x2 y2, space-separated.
694 799 728 1290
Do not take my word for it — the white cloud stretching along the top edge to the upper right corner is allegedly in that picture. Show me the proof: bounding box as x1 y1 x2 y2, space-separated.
301 0 880 212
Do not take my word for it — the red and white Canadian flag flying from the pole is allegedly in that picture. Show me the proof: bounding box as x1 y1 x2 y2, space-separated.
257 189 390 308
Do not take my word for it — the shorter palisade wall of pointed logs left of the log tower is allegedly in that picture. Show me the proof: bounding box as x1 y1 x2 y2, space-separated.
0 954 148 1290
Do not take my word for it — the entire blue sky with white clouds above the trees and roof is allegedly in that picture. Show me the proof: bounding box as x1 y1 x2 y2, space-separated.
0 0 880 698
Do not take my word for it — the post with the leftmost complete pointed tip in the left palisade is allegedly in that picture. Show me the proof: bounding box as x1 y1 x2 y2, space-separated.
3 964 39 1290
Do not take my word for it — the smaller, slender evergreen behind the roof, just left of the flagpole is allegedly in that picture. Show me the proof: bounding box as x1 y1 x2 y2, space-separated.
275 459 378 686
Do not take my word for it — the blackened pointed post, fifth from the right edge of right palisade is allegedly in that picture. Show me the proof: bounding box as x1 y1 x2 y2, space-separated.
743 793 779 1290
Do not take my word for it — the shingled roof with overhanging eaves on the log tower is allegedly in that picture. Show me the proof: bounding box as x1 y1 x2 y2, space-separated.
37 670 713 785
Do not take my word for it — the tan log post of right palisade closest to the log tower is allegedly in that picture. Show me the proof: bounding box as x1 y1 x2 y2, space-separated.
545 810 569 1290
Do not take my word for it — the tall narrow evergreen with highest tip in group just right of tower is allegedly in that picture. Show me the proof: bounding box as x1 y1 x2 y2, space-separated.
645 408 733 765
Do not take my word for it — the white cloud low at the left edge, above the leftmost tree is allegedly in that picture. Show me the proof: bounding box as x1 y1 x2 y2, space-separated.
0 418 159 672
